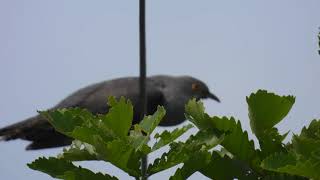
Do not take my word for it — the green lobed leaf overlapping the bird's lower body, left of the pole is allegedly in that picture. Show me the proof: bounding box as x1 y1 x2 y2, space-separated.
40 96 133 140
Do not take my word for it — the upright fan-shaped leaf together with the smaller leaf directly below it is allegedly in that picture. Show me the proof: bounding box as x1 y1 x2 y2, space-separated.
247 90 295 158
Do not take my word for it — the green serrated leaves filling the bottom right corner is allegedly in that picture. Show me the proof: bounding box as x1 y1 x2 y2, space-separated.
261 120 320 179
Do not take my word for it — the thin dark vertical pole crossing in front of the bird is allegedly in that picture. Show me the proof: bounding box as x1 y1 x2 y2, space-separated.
139 0 148 180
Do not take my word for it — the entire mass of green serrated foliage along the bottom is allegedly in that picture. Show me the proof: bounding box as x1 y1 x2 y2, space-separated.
28 90 320 180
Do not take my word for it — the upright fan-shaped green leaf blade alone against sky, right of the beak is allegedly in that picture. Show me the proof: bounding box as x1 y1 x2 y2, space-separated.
247 90 295 138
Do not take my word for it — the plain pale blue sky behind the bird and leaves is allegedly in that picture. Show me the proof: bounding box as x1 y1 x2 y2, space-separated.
0 0 320 180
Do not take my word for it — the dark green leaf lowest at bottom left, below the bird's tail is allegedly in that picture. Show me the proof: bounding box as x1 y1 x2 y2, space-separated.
28 157 117 180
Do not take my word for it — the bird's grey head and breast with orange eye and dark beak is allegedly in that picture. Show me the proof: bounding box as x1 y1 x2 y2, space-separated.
150 75 220 126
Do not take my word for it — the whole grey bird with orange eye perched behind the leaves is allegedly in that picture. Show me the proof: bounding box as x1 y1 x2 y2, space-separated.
0 75 220 150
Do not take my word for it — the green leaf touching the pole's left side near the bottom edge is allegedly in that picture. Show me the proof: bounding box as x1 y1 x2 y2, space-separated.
63 130 140 177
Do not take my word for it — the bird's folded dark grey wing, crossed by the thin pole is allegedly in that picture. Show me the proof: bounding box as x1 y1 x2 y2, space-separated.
55 78 165 121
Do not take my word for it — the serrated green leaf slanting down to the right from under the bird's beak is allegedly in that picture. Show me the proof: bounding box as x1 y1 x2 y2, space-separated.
186 100 259 166
